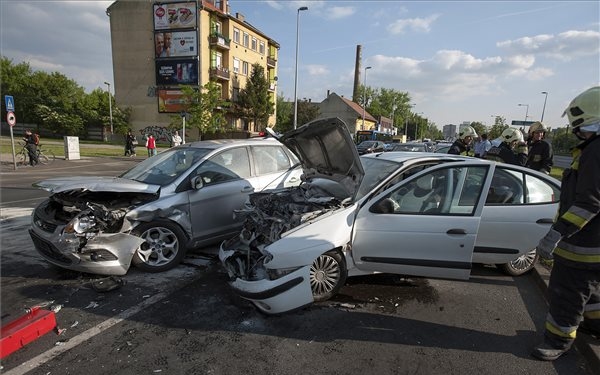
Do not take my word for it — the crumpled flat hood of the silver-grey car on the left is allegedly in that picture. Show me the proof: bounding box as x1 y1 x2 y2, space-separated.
33 176 160 194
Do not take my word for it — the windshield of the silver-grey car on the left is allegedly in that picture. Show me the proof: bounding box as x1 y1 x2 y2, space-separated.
119 147 212 186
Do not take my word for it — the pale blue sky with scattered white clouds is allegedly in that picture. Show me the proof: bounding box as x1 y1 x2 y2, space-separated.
0 0 600 129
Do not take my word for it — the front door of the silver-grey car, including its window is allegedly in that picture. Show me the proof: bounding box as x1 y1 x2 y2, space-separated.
188 147 255 239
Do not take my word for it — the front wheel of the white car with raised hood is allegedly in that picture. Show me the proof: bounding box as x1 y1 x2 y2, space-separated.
310 251 346 302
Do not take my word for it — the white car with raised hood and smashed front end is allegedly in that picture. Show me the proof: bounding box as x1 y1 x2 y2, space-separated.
219 119 560 314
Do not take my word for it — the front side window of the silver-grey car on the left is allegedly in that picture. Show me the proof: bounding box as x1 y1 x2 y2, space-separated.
196 147 250 185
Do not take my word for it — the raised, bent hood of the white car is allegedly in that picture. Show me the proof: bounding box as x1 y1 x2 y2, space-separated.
268 118 365 198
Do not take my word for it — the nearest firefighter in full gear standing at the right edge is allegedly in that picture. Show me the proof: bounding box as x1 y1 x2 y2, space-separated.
531 86 600 361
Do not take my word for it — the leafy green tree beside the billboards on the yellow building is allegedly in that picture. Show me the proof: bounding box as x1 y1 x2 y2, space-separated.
176 81 229 138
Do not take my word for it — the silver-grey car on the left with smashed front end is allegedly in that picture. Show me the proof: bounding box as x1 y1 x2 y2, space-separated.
29 138 302 275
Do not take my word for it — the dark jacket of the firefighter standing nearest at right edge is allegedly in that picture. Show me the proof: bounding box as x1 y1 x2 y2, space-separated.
553 135 600 270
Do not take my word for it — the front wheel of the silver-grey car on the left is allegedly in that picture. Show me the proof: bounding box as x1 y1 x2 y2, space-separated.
132 221 186 272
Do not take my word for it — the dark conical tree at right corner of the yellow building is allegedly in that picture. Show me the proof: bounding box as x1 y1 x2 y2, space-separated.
234 63 275 130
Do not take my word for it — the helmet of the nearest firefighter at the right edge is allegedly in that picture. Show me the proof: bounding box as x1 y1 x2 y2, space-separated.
563 86 600 133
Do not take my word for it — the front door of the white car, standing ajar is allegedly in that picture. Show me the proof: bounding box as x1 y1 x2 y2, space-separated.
352 163 489 279
